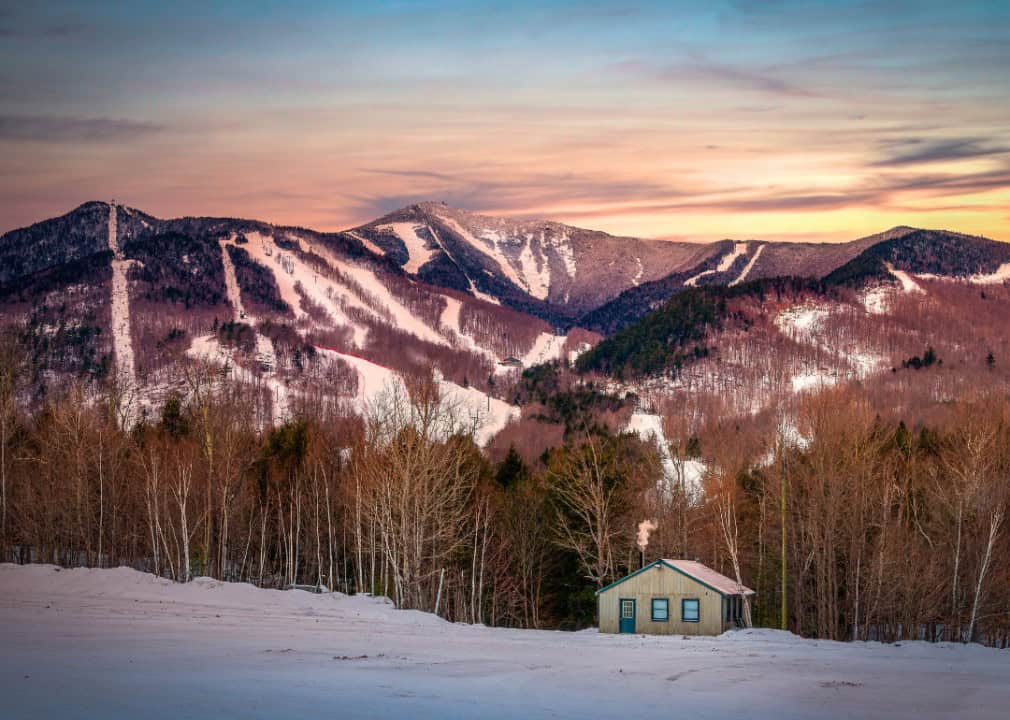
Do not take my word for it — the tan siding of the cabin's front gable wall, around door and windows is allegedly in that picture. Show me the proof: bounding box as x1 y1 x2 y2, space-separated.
597 564 724 635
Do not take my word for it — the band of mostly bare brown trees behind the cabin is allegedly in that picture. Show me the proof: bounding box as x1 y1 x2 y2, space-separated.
0 343 1010 645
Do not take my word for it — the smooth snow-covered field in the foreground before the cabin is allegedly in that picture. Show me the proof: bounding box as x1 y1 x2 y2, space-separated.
0 564 1010 720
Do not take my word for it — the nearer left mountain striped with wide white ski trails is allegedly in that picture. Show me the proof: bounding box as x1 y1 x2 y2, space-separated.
0 202 568 431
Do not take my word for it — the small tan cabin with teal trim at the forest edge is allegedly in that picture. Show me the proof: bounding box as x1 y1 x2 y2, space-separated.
596 559 755 635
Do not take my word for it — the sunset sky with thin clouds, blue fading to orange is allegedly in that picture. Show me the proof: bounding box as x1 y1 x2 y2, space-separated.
0 0 1010 241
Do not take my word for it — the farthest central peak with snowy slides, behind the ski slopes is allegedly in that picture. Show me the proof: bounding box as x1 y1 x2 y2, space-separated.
344 203 717 325
